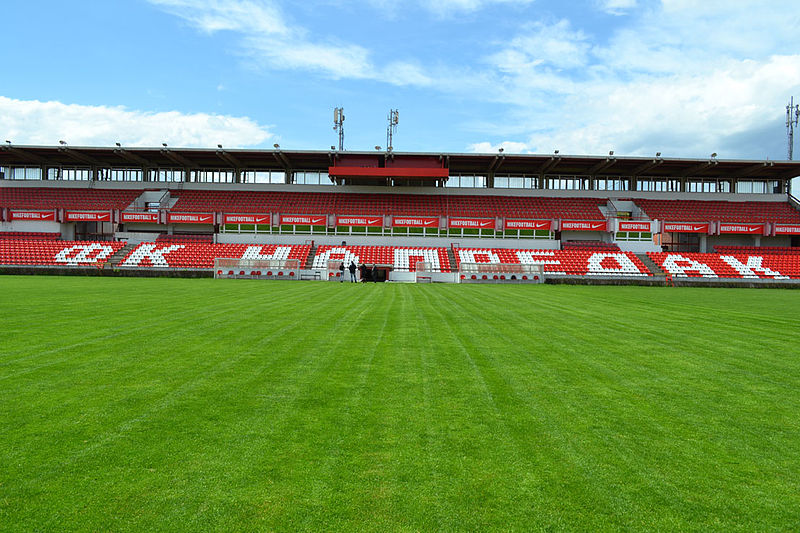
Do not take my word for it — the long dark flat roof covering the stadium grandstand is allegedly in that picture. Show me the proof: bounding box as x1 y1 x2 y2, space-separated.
0 144 800 180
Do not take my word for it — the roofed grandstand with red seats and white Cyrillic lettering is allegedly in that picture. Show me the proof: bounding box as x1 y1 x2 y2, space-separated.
0 144 800 282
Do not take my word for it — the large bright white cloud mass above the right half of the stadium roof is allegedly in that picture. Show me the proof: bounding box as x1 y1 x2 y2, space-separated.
471 0 800 157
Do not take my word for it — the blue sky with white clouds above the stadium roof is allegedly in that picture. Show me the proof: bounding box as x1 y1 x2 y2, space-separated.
0 0 800 160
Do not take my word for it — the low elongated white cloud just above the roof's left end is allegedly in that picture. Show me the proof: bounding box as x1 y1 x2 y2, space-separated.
0 96 273 148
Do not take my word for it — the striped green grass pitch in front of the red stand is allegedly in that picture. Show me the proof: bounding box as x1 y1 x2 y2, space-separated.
0 276 800 532
